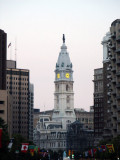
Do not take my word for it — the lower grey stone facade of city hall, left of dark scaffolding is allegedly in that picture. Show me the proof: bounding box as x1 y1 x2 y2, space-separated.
34 115 66 151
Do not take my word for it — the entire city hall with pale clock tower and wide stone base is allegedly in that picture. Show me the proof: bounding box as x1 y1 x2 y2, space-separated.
33 35 93 151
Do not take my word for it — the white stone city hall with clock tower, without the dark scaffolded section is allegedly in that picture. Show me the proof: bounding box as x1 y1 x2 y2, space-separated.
34 35 76 151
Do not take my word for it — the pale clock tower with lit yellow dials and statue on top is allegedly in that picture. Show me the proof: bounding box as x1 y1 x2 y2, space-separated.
52 34 75 129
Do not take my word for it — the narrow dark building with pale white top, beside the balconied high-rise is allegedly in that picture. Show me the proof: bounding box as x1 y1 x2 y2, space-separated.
102 32 114 139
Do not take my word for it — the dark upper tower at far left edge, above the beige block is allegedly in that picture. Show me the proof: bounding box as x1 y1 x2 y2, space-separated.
0 29 7 90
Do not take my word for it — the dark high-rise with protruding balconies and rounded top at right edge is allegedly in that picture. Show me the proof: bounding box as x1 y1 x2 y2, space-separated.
108 19 120 137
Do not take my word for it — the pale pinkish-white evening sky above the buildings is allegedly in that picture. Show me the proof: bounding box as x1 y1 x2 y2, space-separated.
0 0 120 111
